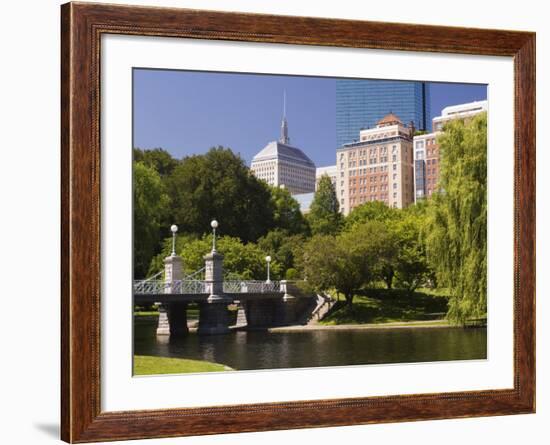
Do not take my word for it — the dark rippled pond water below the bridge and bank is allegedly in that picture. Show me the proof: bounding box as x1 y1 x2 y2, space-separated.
134 317 487 370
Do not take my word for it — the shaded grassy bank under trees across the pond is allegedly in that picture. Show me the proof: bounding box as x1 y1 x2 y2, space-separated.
321 289 448 325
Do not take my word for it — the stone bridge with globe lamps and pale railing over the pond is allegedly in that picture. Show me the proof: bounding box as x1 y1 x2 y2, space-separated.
134 231 317 336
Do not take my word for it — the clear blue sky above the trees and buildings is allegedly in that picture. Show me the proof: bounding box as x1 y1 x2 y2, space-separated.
134 69 487 166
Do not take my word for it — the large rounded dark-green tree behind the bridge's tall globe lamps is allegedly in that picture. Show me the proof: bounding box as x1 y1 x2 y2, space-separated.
167 147 274 242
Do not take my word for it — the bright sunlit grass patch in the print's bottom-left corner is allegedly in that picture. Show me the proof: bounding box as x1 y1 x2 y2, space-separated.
134 355 233 375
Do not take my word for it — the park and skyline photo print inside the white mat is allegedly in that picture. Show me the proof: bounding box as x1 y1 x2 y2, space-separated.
133 68 488 375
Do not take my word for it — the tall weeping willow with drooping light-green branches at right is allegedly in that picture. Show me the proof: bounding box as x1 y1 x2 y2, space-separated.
426 113 487 324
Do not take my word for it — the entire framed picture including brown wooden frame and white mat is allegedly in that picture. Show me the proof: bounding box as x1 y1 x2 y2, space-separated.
60 3 536 443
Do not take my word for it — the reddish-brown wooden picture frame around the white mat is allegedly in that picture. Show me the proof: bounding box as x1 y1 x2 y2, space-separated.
61 3 535 443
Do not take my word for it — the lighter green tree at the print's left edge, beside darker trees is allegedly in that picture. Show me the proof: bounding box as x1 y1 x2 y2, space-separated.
134 162 169 278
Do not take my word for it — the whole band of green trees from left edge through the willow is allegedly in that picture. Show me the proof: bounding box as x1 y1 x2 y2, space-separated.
134 114 487 323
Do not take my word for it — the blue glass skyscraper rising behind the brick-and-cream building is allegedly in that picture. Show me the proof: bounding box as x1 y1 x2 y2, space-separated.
336 79 430 147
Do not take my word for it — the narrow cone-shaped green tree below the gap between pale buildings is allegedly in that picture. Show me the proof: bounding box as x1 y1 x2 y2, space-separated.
307 174 342 235
